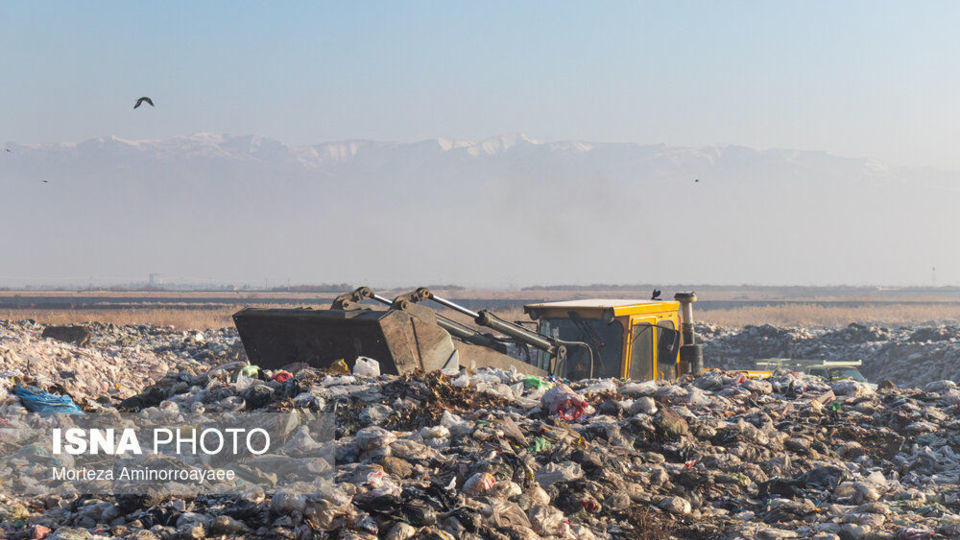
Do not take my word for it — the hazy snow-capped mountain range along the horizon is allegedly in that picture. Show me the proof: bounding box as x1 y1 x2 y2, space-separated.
0 133 960 286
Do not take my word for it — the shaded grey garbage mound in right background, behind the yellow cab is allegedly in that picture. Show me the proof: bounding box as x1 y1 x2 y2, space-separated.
697 324 960 386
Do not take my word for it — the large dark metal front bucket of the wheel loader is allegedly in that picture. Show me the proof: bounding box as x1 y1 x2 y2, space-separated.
233 308 459 375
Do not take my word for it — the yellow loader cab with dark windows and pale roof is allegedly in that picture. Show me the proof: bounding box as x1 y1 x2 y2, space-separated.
523 299 681 380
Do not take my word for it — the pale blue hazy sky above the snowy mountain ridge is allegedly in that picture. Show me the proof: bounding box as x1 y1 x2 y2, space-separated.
0 0 960 170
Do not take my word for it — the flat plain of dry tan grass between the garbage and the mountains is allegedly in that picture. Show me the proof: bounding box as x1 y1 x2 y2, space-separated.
0 287 960 329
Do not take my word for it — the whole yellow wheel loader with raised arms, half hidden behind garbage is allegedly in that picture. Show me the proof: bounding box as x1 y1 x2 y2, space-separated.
233 287 703 380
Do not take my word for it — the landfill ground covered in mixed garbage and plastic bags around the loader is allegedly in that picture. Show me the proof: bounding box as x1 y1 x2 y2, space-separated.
0 321 960 540
